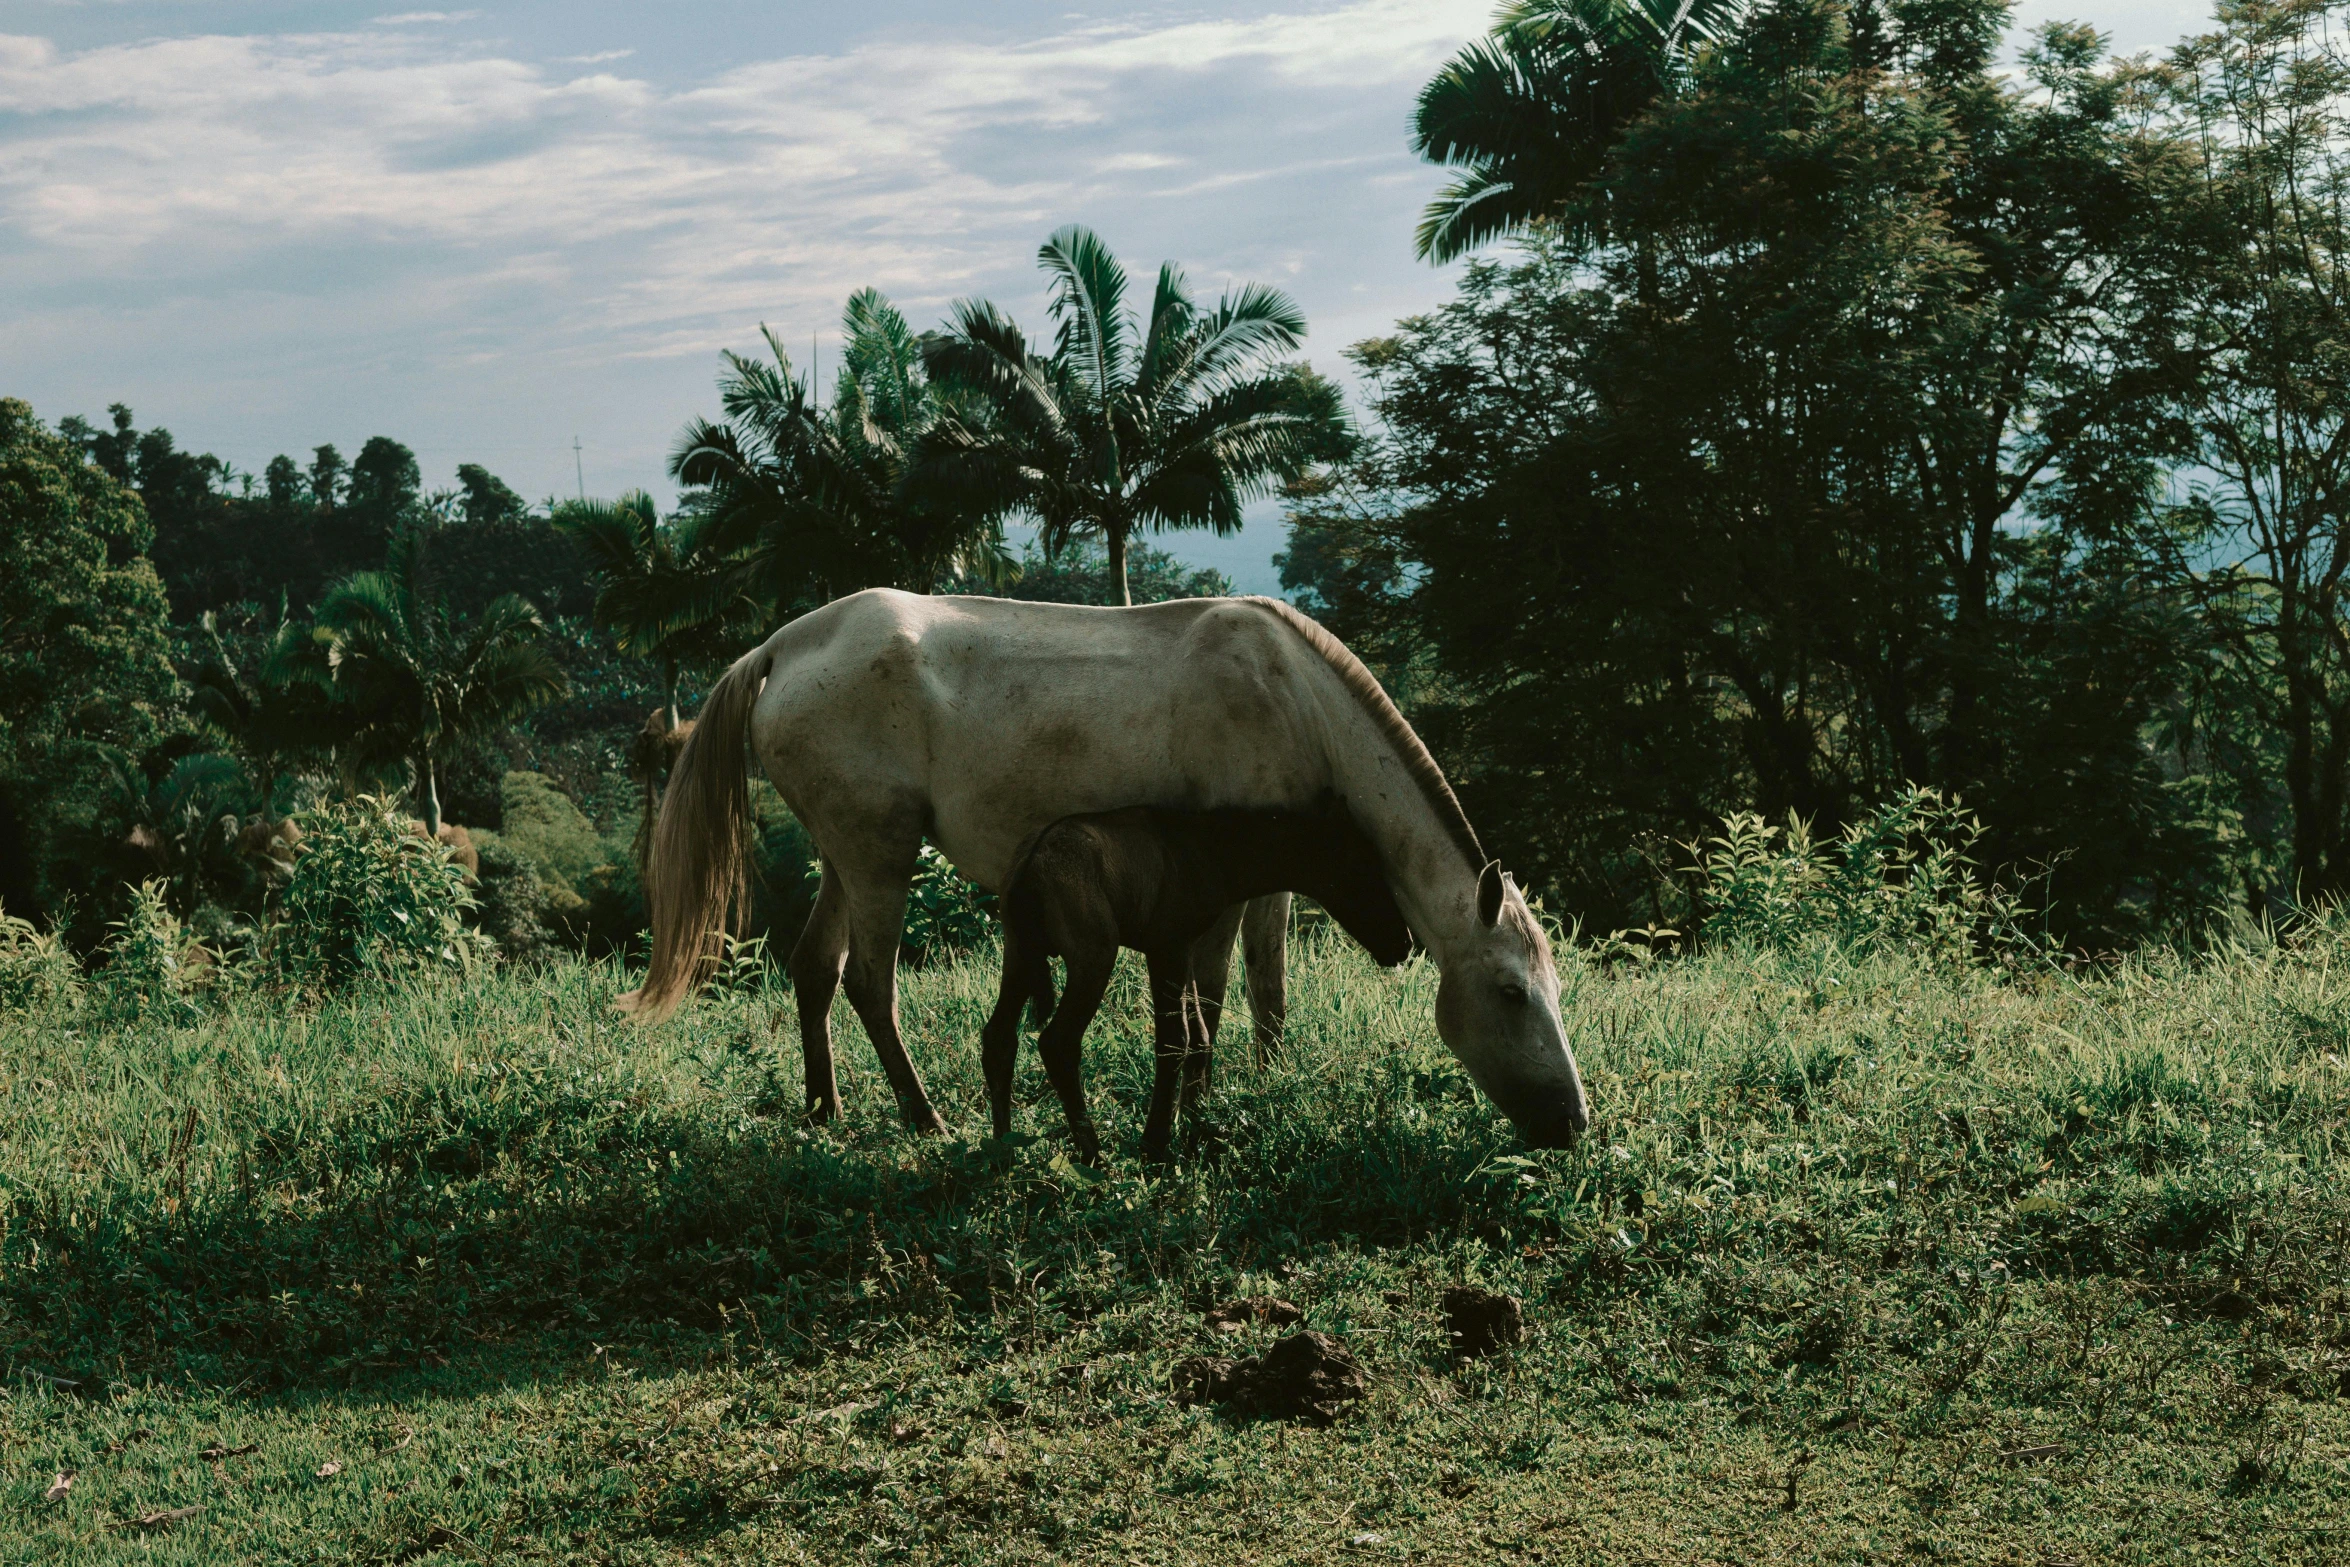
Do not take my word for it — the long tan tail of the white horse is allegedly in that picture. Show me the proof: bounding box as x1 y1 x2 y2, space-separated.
618 646 768 1022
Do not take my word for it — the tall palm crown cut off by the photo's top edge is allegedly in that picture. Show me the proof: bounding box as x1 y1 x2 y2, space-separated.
1412 0 1748 261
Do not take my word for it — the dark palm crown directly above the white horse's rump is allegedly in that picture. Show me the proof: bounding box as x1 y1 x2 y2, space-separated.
670 289 1006 616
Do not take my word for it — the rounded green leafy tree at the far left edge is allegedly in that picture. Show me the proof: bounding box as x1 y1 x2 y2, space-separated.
0 397 172 916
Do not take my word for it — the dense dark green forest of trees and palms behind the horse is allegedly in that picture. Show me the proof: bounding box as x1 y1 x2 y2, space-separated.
0 0 2350 954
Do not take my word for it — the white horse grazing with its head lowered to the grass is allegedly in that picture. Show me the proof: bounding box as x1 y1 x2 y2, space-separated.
620 587 1591 1146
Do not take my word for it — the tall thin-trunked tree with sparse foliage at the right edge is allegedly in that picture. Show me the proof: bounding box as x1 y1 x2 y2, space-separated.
2143 0 2350 900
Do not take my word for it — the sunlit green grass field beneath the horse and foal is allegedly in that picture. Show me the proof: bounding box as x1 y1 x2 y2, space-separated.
0 933 2350 1567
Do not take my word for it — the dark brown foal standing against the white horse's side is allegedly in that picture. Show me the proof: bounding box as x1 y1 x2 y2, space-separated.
980 801 1412 1163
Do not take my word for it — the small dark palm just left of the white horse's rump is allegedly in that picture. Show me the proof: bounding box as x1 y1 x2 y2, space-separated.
555 489 754 728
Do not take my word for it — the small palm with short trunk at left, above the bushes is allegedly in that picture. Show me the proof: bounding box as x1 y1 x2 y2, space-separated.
313 529 571 836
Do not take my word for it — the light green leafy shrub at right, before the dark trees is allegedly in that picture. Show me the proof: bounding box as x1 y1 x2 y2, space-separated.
1694 785 2040 961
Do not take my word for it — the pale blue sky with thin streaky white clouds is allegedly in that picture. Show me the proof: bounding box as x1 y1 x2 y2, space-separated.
0 0 2207 592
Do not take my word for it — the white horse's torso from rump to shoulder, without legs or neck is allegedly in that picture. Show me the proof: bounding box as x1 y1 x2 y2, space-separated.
754 590 1330 888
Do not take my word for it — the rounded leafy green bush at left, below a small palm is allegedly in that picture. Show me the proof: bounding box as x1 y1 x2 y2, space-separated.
270 794 489 987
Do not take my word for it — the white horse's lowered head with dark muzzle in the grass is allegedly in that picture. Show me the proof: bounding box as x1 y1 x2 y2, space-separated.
1436 862 1591 1149
